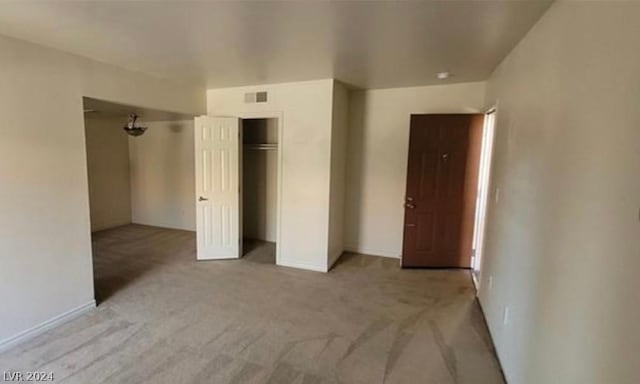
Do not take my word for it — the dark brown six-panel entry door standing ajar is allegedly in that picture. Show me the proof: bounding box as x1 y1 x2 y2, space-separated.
402 115 473 268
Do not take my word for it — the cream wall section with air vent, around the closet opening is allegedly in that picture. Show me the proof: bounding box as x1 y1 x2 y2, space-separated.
207 79 333 271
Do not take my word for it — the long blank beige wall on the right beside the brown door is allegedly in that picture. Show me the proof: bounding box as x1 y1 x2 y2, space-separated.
480 2 640 384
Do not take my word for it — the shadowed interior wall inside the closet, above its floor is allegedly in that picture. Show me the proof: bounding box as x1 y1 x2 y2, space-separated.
242 119 278 242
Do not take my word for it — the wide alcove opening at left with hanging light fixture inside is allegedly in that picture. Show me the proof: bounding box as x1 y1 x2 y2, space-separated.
82 97 195 304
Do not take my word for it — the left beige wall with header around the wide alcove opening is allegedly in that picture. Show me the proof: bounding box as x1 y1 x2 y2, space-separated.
0 36 204 348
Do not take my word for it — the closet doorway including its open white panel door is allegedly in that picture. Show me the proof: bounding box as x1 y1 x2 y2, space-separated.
194 113 282 264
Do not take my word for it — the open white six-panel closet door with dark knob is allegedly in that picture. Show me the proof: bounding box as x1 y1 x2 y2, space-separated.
194 116 242 260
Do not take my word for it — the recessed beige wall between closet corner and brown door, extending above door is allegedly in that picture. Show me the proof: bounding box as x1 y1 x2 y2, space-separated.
345 83 485 257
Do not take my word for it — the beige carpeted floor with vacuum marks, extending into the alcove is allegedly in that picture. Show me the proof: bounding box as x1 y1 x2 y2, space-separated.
0 225 503 384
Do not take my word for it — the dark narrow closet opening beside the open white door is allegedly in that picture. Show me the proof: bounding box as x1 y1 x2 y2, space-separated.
241 118 279 264
